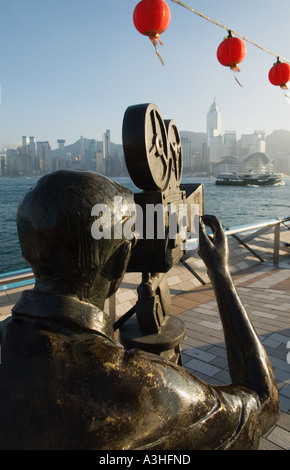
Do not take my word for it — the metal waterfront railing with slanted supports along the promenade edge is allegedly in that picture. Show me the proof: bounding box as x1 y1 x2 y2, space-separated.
0 217 290 294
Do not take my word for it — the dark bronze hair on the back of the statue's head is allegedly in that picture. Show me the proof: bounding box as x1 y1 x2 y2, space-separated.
17 170 133 290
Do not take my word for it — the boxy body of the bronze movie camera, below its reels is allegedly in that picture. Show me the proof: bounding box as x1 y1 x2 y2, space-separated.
127 184 204 273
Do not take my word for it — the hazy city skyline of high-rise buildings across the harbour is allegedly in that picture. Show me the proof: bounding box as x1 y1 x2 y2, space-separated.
0 99 290 180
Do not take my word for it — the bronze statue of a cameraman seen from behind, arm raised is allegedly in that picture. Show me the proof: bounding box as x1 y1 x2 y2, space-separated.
0 171 279 450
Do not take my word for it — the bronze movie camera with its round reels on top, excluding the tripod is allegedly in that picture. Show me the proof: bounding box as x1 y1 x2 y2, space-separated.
123 104 204 273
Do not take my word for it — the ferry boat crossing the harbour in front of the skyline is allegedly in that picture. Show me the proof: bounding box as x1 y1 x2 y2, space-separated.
215 172 284 186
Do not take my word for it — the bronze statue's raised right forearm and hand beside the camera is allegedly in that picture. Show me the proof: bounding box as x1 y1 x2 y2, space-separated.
199 216 279 431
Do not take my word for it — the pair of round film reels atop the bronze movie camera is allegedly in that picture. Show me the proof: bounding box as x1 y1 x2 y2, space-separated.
122 103 182 191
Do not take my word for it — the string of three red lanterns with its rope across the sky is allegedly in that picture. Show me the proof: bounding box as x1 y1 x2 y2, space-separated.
133 0 290 89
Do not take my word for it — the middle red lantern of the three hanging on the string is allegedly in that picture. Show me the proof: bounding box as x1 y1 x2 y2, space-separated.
217 31 247 72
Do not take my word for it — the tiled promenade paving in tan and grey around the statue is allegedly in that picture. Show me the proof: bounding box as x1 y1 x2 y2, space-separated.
0 222 290 450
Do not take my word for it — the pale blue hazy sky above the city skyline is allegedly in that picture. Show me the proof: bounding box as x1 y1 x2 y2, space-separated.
0 0 290 148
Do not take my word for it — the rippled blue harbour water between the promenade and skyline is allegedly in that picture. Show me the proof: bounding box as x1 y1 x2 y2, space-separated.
0 177 290 273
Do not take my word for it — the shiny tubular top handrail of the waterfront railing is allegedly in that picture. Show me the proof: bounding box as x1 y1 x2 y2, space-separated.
0 217 290 292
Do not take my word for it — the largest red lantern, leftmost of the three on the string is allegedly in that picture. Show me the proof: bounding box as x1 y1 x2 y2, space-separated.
133 0 171 47
